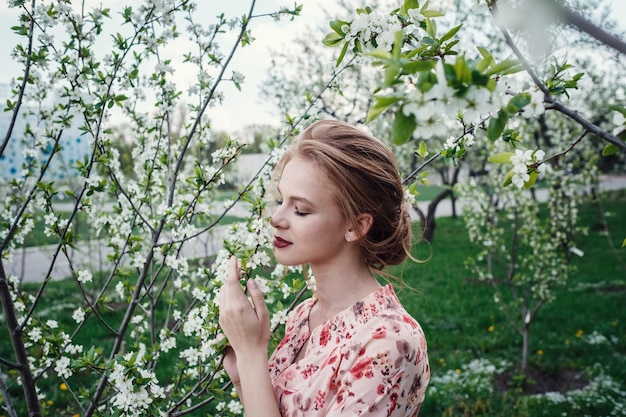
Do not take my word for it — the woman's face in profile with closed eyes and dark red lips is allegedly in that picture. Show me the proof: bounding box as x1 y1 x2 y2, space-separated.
270 158 350 267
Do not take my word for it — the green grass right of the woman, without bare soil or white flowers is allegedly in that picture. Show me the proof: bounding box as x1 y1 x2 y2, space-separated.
397 192 626 416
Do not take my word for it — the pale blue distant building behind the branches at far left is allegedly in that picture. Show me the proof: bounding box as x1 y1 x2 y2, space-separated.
0 83 91 180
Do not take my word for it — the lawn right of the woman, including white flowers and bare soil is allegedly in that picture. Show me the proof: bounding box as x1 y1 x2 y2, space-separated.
396 192 626 416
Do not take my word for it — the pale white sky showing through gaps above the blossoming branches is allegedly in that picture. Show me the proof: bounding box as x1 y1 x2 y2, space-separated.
0 0 626 132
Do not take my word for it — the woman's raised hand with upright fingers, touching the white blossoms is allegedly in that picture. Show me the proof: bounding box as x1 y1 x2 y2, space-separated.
219 256 270 356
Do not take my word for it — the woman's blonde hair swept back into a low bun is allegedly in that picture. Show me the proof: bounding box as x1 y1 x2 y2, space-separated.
275 120 411 271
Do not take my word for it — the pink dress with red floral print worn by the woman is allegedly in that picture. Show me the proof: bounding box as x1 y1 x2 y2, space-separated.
269 285 430 417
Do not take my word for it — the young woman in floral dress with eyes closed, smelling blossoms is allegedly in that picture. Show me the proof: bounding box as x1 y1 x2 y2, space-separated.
220 121 430 417
